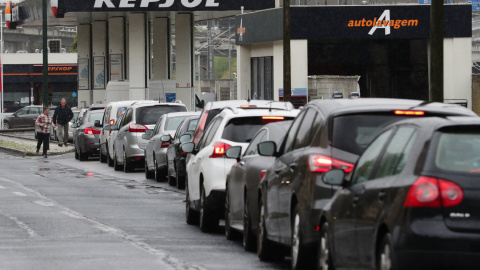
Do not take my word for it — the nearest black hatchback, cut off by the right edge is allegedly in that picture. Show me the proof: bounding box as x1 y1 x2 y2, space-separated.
317 117 480 269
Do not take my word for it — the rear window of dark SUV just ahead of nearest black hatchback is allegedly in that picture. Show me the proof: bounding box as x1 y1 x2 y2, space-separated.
331 114 405 155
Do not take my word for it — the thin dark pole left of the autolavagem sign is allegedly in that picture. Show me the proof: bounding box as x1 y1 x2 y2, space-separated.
283 0 292 101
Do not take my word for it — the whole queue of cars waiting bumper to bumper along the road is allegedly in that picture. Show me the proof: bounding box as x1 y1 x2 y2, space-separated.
70 98 480 270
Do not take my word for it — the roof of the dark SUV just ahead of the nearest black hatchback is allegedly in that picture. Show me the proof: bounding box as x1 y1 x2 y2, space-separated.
307 98 477 116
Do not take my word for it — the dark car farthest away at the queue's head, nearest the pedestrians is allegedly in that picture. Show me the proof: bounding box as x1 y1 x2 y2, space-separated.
72 110 104 161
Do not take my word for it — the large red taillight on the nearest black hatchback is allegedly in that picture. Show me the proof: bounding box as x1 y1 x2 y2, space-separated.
403 176 463 207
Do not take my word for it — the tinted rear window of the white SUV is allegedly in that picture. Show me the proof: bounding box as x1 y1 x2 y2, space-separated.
222 116 293 143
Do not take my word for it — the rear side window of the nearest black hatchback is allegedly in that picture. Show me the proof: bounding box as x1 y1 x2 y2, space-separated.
374 127 415 178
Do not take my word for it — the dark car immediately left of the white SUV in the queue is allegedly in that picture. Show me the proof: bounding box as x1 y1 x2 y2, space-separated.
167 114 200 189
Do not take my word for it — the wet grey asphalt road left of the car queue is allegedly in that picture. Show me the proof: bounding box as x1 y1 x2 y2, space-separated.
0 152 289 270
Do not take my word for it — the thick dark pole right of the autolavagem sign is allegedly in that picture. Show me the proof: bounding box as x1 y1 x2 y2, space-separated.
430 0 445 103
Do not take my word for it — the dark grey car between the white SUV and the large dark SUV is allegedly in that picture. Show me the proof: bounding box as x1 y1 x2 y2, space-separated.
225 120 293 251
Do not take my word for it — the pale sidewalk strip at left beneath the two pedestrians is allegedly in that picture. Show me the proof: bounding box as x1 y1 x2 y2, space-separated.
0 134 75 156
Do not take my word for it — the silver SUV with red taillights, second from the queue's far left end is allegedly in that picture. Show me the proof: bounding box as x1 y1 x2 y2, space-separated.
109 103 187 172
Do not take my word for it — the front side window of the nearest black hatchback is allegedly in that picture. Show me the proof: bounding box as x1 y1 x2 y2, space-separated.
352 129 392 185
